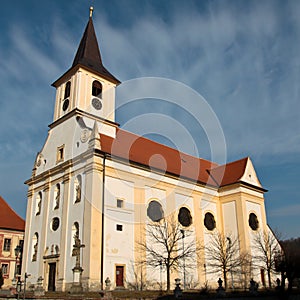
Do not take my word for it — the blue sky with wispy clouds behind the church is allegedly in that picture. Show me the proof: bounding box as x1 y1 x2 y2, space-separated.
0 0 300 238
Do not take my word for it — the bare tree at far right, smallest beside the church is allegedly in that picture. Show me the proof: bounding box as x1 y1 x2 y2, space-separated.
252 230 281 288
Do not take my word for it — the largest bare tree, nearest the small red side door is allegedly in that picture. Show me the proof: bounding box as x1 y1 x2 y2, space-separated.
138 216 200 291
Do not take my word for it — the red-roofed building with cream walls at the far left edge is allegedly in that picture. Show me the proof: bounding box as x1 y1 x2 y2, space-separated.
0 196 25 288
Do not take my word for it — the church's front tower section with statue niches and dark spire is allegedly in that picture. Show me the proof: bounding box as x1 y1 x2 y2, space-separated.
23 8 120 291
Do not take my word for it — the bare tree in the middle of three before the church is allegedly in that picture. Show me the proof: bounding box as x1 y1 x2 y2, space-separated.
205 232 248 289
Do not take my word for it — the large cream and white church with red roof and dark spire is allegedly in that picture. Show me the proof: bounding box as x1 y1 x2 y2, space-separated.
22 10 278 291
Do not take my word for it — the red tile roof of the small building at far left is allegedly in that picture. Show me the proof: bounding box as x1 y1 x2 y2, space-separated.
0 196 25 231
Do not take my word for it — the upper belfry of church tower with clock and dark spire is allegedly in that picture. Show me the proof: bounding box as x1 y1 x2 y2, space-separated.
52 7 120 128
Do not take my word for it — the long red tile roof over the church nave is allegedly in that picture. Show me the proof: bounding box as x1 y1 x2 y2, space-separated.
100 128 254 187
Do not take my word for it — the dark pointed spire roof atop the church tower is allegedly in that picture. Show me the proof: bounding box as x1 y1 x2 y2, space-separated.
52 17 120 86
